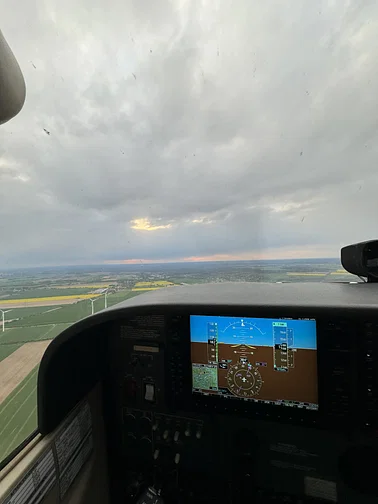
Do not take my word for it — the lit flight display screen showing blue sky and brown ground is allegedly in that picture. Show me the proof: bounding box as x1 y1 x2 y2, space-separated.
190 315 318 410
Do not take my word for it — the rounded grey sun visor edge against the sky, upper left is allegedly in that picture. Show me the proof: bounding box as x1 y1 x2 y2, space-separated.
0 31 26 124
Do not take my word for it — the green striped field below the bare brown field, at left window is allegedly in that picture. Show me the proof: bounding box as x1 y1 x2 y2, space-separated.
0 366 39 461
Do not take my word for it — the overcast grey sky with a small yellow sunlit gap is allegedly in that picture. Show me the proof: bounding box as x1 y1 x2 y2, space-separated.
0 0 378 267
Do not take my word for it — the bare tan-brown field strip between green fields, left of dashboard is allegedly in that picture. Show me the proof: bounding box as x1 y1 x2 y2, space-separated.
0 340 51 404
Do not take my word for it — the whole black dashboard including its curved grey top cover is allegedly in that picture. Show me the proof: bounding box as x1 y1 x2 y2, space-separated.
38 283 378 503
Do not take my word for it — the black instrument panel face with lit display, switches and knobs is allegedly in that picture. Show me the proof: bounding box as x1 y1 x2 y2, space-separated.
103 313 378 503
